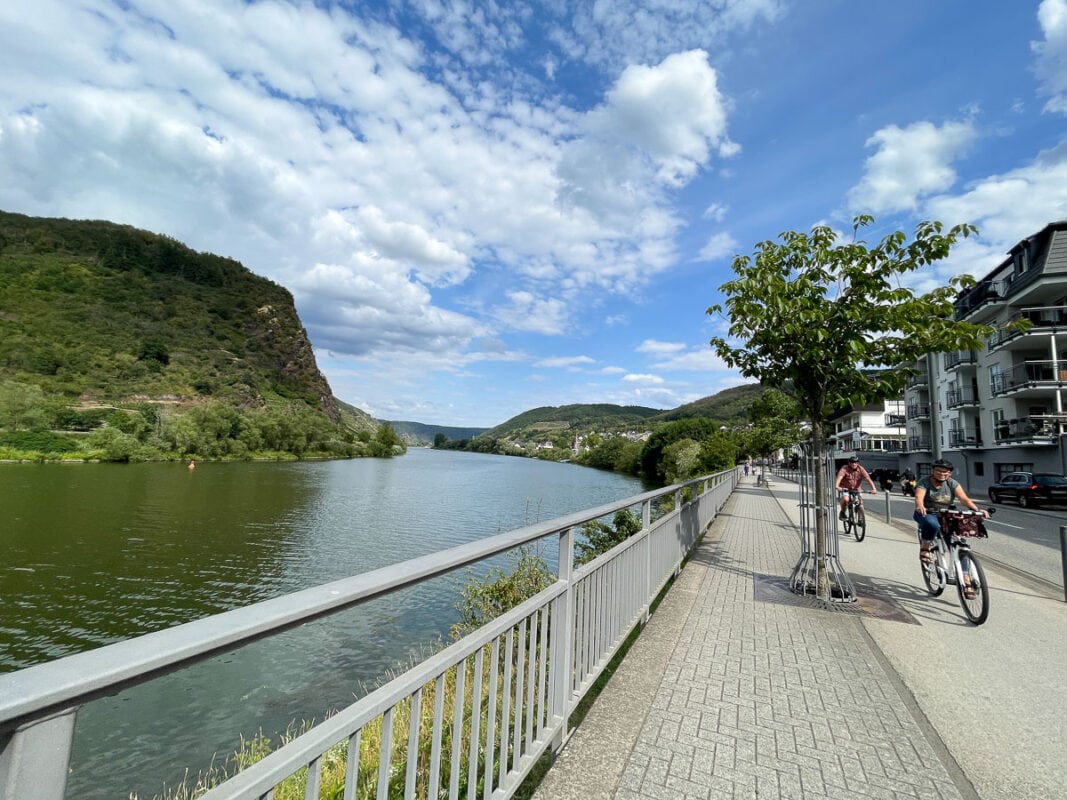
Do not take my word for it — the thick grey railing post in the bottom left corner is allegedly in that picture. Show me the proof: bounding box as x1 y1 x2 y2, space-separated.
0 708 77 800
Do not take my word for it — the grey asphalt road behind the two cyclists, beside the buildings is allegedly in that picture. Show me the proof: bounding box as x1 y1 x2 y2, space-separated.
863 491 1067 597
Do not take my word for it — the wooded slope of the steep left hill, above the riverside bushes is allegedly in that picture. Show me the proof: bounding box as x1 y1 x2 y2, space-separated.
0 211 388 450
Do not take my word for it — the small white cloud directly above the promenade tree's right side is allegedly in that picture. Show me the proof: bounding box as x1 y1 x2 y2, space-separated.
848 121 975 214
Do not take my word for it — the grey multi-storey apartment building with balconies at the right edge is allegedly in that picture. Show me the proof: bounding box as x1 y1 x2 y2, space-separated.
901 221 1067 496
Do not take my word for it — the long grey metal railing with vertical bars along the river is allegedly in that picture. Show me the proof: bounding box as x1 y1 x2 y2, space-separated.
0 469 737 800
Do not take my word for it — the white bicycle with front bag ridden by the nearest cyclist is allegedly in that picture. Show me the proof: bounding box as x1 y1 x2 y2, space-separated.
919 508 993 625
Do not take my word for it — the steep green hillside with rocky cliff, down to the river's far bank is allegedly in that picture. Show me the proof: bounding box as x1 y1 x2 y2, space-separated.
0 211 391 458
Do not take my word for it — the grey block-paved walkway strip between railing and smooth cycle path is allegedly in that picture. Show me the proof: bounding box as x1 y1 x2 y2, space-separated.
539 486 961 800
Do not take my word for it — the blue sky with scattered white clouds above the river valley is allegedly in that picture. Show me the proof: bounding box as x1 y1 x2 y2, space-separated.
0 0 1067 427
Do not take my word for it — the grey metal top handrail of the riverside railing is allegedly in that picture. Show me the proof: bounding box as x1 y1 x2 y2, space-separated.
0 481 665 732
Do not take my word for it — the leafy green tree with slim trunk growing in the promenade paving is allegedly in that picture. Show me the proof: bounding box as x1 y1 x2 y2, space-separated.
707 215 991 602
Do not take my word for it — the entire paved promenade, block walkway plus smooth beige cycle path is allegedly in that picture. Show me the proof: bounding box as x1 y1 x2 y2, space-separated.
535 478 1067 800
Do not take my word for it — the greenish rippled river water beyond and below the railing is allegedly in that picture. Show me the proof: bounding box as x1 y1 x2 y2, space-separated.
0 449 643 800
